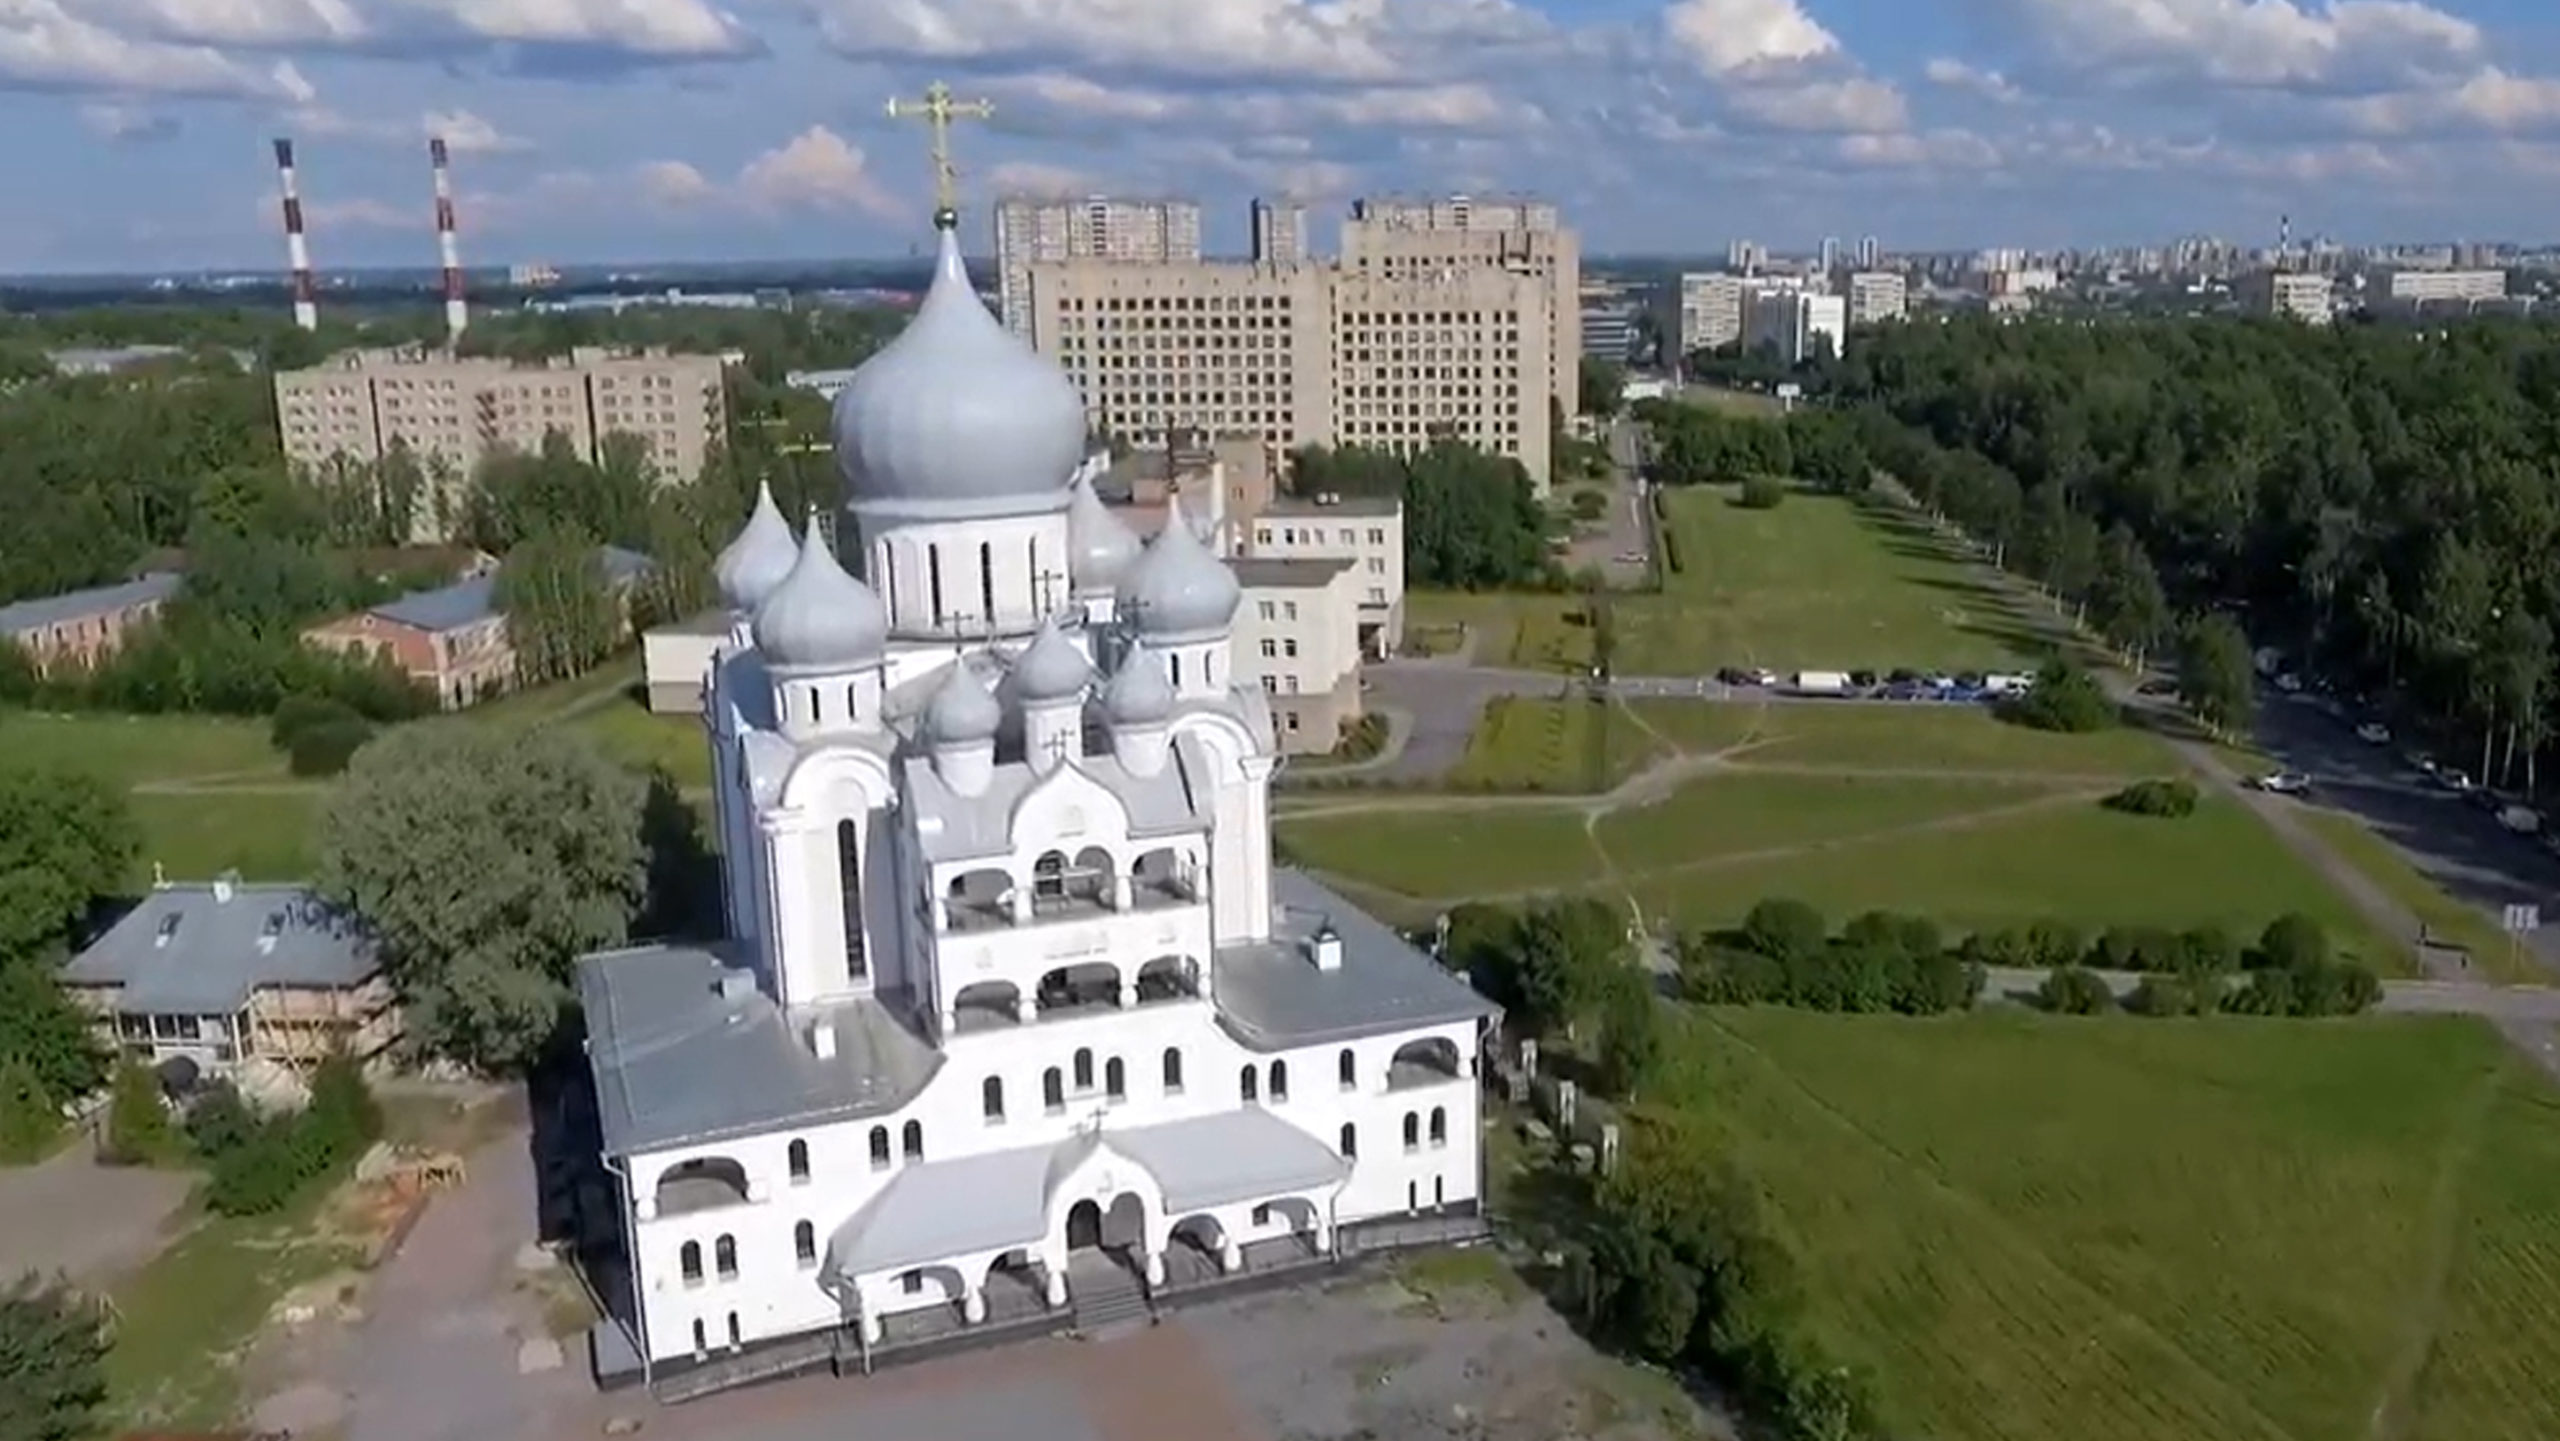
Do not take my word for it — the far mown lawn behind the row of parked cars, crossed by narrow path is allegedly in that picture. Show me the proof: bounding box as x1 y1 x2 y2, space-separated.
1408 486 2045 676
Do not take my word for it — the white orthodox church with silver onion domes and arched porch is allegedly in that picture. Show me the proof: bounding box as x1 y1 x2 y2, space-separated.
579 212 1495 1369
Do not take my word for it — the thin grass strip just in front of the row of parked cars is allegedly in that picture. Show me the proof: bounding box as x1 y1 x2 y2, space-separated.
1633 701 2179 776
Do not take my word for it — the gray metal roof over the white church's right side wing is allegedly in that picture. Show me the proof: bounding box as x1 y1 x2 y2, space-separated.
1211 870 1500 1052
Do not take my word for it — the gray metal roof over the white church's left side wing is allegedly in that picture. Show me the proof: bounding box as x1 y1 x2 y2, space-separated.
579 944 942 1157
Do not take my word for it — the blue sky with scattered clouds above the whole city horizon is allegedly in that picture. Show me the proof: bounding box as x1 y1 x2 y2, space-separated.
0 0 2560 271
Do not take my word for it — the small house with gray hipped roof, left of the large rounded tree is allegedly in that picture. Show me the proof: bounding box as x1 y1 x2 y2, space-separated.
61 875 399 1072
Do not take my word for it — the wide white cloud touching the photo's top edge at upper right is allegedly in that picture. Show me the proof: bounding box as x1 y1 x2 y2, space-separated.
1989 0 2481 90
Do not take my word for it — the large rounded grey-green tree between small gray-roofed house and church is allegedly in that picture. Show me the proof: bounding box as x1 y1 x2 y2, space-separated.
317 727 648 1070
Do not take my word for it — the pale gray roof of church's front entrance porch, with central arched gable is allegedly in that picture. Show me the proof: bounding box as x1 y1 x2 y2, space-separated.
827 1106 1349 1275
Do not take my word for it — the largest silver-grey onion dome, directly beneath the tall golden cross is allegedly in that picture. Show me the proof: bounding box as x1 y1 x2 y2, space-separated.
835 225 1085 520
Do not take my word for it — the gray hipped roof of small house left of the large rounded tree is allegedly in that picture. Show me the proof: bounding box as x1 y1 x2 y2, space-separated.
61 883 379 1016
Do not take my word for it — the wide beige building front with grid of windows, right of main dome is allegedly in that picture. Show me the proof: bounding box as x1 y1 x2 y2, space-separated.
1032 254 1574 491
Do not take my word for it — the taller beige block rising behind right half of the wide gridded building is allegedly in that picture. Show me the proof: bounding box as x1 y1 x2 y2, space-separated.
1341 195 1582 432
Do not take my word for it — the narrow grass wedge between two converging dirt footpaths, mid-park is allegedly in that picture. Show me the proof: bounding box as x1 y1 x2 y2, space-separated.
1600 770 2051 873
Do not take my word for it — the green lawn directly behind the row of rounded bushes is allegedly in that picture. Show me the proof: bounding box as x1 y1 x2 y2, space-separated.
1636 799 2409 975
